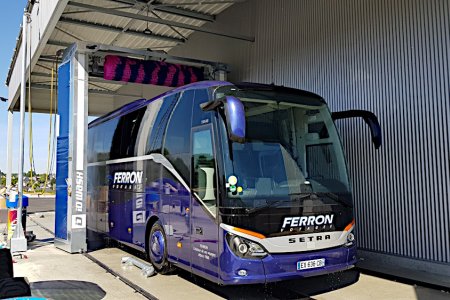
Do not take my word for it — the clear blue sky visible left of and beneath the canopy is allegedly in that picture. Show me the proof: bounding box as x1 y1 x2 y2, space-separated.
0 0 53 173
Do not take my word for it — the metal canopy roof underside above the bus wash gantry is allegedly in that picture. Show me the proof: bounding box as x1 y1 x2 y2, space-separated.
7 0 254 115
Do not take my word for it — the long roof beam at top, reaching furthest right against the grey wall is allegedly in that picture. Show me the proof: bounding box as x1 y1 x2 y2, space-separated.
69 1 255 42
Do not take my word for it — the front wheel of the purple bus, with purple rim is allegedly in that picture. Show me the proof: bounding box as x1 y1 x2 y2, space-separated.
148 221 173 274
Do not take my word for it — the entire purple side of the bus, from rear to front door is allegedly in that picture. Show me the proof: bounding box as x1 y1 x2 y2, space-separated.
88 85 220 280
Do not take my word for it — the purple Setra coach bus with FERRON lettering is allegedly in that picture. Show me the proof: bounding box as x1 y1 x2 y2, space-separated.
87 81 381 285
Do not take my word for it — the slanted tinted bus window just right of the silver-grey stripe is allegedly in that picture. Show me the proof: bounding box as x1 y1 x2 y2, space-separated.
145 94 179 154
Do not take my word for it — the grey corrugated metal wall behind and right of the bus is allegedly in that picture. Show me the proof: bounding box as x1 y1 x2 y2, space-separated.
175 0 450 263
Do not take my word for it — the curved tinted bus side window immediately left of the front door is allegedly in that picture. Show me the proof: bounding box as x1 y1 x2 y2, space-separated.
163 90 194 184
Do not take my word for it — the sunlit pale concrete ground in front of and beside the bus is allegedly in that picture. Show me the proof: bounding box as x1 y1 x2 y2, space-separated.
0 213 450 300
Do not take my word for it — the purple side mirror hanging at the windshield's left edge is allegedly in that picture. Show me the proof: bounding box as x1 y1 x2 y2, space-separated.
200 96 245 143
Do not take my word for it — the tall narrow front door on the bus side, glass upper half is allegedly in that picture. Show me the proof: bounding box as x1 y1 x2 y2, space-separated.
191 125 219 277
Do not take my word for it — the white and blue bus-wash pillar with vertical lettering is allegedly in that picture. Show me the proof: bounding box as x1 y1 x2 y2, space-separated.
55 44 89 253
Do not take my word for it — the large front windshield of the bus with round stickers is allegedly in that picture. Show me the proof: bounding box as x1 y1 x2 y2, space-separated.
215 87 351 209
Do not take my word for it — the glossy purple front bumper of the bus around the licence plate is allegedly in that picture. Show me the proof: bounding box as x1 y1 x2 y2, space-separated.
220 246 357 285
